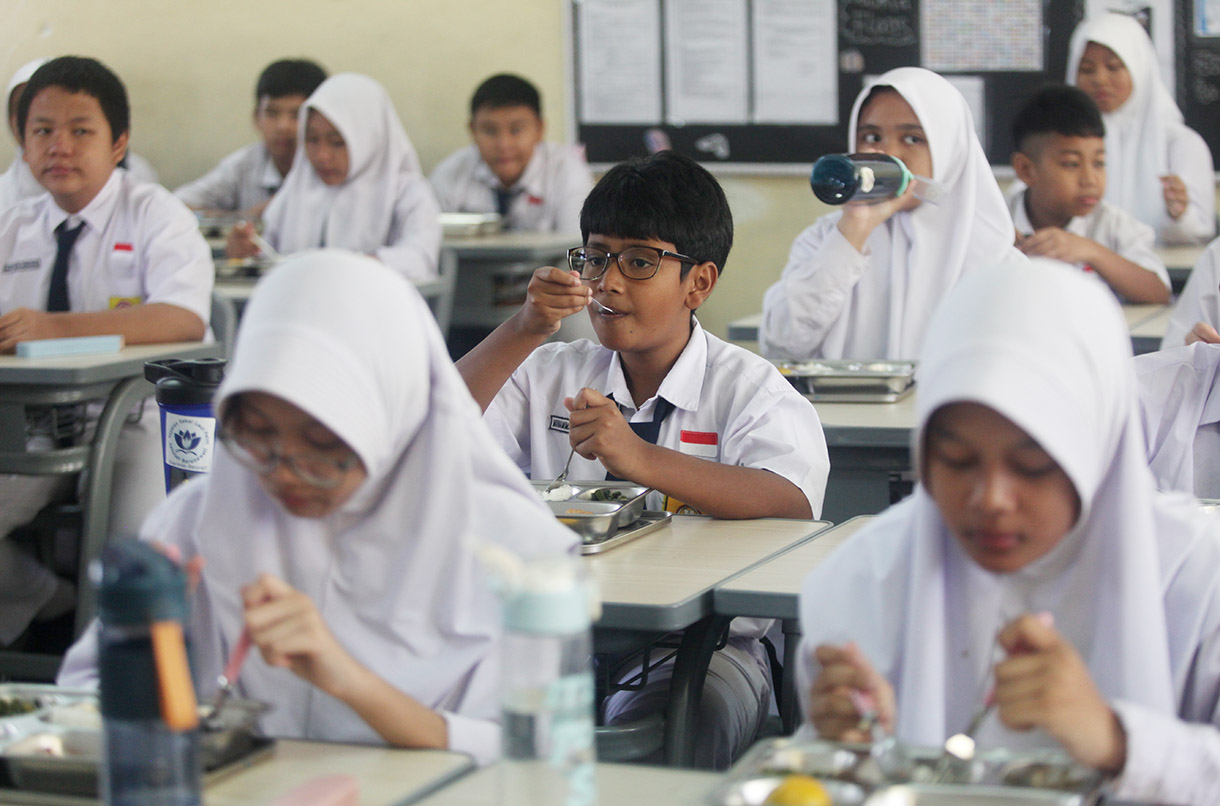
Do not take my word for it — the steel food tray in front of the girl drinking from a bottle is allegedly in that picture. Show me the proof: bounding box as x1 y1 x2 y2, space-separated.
775 360 916 402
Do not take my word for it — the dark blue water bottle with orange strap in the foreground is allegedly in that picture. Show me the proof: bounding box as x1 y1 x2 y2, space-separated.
98 540 201 806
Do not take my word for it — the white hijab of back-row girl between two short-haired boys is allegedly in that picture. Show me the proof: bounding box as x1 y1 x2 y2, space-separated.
262 73 423 254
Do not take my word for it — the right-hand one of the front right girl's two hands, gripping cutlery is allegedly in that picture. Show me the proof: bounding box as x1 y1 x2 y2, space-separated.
996 613 1126 773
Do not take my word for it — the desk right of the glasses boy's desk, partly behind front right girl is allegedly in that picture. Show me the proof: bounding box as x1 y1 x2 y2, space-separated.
712 515 872 733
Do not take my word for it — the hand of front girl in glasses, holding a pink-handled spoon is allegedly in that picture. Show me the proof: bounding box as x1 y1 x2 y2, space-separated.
242 574 361 700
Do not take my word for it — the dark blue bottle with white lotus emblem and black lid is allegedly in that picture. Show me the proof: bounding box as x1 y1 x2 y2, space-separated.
144 358 224 494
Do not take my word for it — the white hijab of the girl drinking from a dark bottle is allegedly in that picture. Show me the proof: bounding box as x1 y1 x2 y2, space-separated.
824 67 1022 358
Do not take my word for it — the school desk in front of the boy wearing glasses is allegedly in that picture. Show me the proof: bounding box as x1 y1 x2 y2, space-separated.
584 516 830 767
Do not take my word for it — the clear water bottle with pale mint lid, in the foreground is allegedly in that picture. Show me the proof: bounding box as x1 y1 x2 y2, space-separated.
500 557 597 806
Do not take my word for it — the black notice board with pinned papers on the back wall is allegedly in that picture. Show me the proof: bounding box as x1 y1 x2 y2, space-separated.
569 0 1161 172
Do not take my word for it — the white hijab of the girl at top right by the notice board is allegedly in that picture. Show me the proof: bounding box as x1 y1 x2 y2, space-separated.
1068 13 1185 229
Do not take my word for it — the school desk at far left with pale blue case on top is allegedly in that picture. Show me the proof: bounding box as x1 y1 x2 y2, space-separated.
0 341 220 665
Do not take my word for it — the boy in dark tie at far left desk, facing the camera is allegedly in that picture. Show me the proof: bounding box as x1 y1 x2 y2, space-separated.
0 56 214 645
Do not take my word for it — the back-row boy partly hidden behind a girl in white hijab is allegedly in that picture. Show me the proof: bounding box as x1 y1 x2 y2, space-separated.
173 59 326 218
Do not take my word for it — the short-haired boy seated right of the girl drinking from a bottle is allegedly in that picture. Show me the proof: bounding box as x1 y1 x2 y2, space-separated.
1009 87 1169 302
